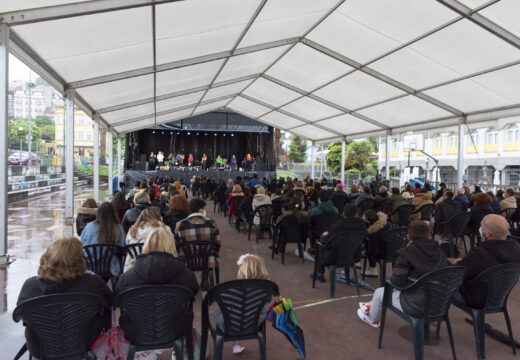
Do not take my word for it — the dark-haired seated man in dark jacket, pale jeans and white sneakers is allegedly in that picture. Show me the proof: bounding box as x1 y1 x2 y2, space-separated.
357 220 450 328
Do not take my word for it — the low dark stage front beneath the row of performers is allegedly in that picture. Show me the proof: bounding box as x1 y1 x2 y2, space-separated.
125 169 276 186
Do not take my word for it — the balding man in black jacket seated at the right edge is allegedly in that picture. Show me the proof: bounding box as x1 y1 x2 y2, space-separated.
455 214 520 309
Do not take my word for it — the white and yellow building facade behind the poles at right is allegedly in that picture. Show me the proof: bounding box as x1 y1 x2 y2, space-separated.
378 117 520 186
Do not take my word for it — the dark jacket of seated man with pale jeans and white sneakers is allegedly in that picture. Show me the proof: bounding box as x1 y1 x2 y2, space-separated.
390 239 450 317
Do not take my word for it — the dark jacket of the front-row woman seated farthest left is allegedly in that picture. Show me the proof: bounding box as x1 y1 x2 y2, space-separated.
17 273 112 358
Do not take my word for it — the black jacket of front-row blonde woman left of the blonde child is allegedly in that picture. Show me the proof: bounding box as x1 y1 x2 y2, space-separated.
114 252 199 341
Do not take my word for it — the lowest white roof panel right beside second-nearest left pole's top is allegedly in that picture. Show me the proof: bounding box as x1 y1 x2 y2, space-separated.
77 75 153 109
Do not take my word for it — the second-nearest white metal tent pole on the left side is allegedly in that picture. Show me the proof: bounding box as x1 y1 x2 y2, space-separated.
64 89 74 237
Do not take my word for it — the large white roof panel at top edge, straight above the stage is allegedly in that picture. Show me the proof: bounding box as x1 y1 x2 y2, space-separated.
156 0 260 64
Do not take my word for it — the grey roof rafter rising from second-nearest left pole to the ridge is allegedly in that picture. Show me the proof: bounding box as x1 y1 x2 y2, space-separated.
70 37 301 89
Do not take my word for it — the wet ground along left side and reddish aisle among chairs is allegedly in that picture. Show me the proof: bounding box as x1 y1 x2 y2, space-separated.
0 188 520 360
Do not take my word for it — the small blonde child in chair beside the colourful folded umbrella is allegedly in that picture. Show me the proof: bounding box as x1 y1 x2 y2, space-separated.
210 254 269 354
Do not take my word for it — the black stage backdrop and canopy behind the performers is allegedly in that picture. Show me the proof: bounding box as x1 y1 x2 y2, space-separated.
125 112 275 171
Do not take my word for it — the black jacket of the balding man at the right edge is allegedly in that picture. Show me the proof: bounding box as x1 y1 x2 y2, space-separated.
457 240 520 309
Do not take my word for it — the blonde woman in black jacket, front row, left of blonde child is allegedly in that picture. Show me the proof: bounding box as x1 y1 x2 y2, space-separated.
114 227 199 342
